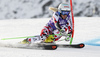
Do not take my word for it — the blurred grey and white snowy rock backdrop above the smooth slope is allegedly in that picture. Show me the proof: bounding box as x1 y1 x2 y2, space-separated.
0 0 100 19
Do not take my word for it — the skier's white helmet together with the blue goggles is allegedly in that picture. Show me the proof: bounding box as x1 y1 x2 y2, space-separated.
58 3 70 15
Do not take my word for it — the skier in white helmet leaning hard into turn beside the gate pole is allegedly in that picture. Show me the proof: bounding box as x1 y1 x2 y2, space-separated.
22 3 72 43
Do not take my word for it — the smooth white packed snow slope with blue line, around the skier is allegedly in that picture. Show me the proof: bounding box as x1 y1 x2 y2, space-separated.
0 17 100 57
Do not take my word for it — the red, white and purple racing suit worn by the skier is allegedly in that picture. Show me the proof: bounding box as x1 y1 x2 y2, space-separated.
28 12 71 42
